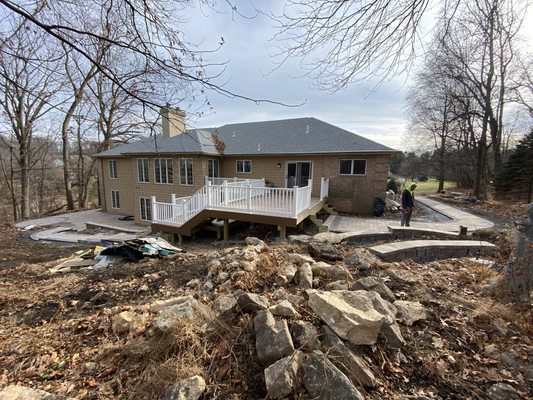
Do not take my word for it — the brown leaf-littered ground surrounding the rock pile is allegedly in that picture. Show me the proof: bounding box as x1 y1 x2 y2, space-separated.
0 203 533 399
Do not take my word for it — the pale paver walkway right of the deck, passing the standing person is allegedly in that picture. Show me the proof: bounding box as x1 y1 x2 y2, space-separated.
324 197 494 233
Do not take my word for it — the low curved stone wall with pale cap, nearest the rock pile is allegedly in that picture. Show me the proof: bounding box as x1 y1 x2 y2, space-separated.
368 240 496 262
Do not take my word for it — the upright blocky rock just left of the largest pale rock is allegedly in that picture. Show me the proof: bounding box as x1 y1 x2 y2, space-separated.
254 311 294 366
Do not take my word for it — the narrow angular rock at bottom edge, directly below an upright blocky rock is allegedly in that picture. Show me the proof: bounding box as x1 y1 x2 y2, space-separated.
265 351 302 399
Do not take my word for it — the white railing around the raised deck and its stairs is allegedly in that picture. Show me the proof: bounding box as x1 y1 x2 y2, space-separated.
152 178 329 226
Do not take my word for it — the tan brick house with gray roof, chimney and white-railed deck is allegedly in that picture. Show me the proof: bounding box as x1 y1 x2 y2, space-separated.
95 107 397 235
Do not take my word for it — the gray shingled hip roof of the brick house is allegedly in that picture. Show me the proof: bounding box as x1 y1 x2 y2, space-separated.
96 118 396 157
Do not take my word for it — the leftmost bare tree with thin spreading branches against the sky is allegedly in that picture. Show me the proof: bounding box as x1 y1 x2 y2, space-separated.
0 19 60 218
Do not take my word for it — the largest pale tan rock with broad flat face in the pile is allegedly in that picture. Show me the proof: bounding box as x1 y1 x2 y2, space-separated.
307 289 385 345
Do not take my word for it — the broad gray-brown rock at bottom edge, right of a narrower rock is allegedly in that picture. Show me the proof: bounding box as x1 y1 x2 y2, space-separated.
302 351 363 400
